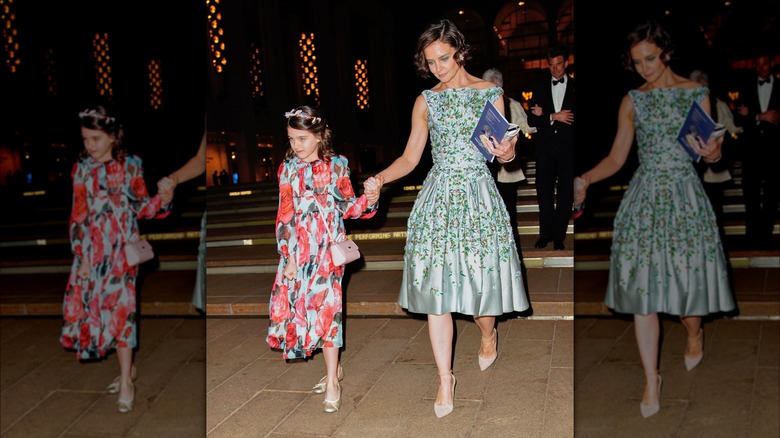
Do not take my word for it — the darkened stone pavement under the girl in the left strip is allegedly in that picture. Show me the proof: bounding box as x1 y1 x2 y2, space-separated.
0 317 206 438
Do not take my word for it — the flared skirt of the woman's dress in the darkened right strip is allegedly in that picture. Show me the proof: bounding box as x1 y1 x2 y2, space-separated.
604 165 735 316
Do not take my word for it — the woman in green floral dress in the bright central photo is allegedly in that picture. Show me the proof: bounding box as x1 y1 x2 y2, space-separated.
366 20 529 418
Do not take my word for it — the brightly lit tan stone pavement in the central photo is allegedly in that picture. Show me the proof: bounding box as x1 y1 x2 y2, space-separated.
206 317 574 438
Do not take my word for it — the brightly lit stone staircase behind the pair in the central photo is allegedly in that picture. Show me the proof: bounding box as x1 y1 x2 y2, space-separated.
206 162 574 318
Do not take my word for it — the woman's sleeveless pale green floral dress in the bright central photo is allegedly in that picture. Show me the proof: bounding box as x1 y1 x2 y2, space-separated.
398 87 529 316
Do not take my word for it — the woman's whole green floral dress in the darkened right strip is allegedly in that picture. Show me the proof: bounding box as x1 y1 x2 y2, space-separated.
605 87 735 316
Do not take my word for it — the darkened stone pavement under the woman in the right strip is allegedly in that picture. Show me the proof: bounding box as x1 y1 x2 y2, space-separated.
574 318 780 438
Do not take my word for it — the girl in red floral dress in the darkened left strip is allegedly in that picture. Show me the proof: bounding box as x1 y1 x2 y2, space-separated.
60 106 173 413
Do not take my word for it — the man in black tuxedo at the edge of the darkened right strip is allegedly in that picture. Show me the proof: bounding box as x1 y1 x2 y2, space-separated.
737 51 780 248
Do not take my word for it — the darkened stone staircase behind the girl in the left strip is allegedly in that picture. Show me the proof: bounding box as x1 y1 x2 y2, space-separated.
0 182 206 316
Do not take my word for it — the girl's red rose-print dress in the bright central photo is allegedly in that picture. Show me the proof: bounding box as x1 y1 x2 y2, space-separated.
266 155 376 359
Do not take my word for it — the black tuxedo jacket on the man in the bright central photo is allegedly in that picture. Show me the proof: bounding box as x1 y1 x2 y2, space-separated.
528 75 576 146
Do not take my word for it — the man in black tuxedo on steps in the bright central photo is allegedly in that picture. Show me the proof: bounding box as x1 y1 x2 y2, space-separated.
528 46 574 250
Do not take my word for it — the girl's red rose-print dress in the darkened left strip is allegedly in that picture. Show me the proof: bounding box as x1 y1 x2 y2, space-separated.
60 156 169 359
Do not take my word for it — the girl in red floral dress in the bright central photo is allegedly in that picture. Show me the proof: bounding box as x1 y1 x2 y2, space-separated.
267 106 379 412
